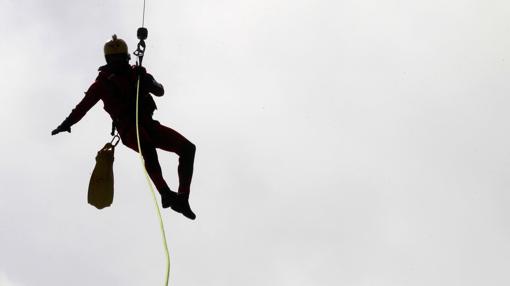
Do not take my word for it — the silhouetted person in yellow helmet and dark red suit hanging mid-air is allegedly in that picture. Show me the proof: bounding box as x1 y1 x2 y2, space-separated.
51 35 195 219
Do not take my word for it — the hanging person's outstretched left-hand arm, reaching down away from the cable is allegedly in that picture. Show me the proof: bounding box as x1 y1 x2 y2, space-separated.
51 81 101 135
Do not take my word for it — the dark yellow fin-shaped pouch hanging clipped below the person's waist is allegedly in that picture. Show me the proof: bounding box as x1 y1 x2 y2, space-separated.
87 135 118 209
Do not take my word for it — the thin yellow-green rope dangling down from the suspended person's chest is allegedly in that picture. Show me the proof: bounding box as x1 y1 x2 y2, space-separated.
136 75 170 286
